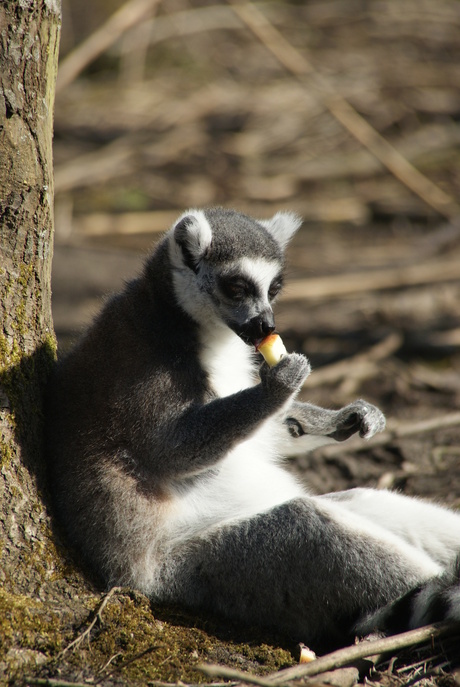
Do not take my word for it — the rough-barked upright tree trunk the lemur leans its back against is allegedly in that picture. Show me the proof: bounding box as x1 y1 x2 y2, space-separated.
0 0 80 677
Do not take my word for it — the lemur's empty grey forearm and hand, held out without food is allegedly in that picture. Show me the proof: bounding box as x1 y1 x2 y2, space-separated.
284 400 385 453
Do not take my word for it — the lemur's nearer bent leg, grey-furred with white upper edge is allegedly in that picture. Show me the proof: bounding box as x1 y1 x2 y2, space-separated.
157 497 441 647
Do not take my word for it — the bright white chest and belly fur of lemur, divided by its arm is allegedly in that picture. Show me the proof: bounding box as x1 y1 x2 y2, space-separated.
165 326 304 546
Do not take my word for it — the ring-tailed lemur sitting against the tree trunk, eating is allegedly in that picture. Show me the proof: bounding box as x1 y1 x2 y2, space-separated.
48 209 460 646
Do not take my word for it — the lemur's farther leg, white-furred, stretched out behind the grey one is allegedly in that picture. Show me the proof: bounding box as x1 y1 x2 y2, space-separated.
313 489 460 566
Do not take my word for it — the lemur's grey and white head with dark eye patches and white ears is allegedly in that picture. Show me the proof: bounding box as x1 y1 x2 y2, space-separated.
168 208 301 344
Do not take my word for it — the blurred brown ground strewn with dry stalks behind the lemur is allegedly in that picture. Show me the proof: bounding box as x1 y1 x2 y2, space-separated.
47 0 460 684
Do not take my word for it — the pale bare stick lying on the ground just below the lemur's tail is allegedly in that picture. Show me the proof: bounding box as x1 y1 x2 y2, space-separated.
199 623 459 687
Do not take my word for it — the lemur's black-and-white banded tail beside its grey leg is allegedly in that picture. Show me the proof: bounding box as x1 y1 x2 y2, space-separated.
356 556 460 635
